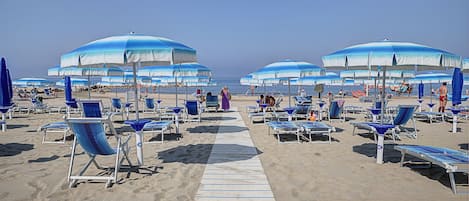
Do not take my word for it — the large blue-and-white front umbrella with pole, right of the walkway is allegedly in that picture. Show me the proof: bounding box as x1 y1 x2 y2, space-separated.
322 40 461 163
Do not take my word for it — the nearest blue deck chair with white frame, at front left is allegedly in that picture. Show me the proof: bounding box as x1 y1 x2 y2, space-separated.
65 118 132 188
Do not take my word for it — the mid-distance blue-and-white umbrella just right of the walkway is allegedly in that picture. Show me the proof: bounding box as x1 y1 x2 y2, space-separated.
253 60 326 107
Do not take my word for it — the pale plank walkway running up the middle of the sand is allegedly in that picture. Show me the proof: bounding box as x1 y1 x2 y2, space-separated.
195 108 275 201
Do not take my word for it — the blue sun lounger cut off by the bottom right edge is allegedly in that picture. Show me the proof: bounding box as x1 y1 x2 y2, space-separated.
394 145 469 194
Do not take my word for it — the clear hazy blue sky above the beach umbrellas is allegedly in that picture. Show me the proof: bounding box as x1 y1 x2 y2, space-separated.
0 0 469 78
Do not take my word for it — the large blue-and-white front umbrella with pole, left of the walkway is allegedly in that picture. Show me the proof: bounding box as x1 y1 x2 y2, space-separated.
60 33 197 165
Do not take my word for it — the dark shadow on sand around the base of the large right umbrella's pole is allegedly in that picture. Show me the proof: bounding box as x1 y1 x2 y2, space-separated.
352 143 401 163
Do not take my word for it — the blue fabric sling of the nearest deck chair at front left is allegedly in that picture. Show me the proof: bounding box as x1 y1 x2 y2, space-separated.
66 118 116 155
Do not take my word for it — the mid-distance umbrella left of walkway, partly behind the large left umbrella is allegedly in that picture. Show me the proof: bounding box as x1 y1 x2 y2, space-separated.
137 62 212 106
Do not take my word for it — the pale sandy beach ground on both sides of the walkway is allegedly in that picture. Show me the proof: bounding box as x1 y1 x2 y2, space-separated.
0 93 469 201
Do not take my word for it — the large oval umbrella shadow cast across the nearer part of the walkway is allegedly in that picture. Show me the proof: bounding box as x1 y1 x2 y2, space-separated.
157 144 262 164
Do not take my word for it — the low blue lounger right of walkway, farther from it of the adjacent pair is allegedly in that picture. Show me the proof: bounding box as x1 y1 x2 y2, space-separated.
296 121 335 144
